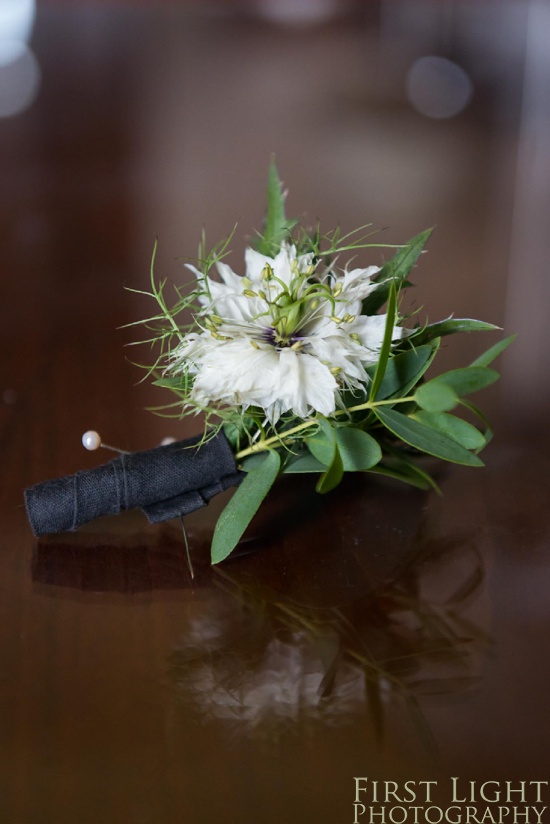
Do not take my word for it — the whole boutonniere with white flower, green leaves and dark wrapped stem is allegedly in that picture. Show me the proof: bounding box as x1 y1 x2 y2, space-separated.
26 164 512 563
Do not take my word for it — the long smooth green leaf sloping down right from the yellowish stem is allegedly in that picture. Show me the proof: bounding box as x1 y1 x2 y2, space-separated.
373 407 483 466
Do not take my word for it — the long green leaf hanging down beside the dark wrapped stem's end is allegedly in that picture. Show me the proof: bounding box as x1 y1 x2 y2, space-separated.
211 450 281 564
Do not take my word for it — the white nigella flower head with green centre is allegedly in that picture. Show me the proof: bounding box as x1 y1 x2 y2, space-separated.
170 244 402 423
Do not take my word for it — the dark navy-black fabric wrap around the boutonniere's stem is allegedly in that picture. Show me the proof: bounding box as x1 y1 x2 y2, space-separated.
25 432 243 537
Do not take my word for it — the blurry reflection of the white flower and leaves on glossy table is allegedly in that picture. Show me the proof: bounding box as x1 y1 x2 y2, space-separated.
170 528 490 744
